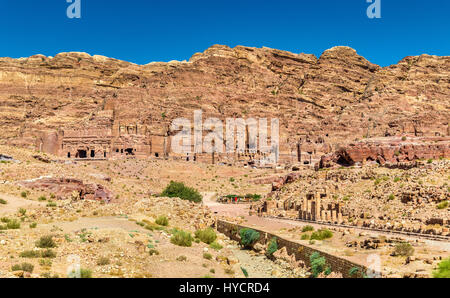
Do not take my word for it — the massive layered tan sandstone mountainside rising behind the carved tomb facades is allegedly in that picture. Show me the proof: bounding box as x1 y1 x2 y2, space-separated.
0 45 450 145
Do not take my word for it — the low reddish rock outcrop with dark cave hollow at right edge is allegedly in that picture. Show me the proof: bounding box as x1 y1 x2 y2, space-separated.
320 137 450 168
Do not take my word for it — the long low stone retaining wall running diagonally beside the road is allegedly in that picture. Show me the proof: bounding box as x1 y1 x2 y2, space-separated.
216 220 378 278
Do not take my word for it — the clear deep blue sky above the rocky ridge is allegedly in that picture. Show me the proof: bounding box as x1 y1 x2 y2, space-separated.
0 0 450 66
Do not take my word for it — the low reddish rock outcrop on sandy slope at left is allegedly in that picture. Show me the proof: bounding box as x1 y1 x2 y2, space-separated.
20 178 113 203
